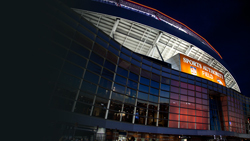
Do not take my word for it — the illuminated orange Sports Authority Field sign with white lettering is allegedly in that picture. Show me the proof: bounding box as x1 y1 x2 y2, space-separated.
180 54 226 86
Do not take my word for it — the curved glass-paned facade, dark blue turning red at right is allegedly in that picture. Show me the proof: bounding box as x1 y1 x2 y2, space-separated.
42 0 250 137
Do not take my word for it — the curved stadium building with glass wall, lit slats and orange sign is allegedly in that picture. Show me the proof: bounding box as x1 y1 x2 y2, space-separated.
44 0 250 141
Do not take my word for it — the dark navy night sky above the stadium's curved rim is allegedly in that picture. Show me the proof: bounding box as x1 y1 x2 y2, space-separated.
133 0 250 97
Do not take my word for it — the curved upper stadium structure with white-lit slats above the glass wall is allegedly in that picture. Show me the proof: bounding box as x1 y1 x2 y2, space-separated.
73 0 240 92
